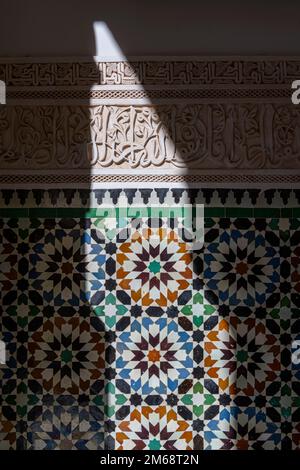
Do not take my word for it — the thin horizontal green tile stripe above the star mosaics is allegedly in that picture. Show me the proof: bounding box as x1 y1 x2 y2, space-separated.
0 206 300 219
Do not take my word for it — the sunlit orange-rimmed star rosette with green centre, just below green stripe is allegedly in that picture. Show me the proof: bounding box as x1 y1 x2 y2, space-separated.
117 228 192 307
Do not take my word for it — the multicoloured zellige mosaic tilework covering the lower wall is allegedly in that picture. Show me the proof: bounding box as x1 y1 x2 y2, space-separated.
0 188 300 450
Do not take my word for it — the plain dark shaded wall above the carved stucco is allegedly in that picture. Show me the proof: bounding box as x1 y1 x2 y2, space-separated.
0 0 300 57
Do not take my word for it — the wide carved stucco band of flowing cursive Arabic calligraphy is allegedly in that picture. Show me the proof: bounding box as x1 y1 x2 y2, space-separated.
0 103 300 169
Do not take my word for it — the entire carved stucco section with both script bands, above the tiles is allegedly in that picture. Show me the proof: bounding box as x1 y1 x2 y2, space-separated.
0 57 300 183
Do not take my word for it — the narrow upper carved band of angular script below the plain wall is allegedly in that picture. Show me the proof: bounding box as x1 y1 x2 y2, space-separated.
0 57 300 87
